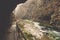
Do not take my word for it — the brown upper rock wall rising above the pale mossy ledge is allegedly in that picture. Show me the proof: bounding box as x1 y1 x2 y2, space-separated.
14 0 60 29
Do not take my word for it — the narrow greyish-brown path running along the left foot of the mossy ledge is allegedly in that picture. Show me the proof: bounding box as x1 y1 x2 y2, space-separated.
7 22 17 40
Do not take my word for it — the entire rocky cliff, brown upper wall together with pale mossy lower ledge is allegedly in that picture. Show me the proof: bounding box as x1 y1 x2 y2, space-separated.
13 0 60 40
